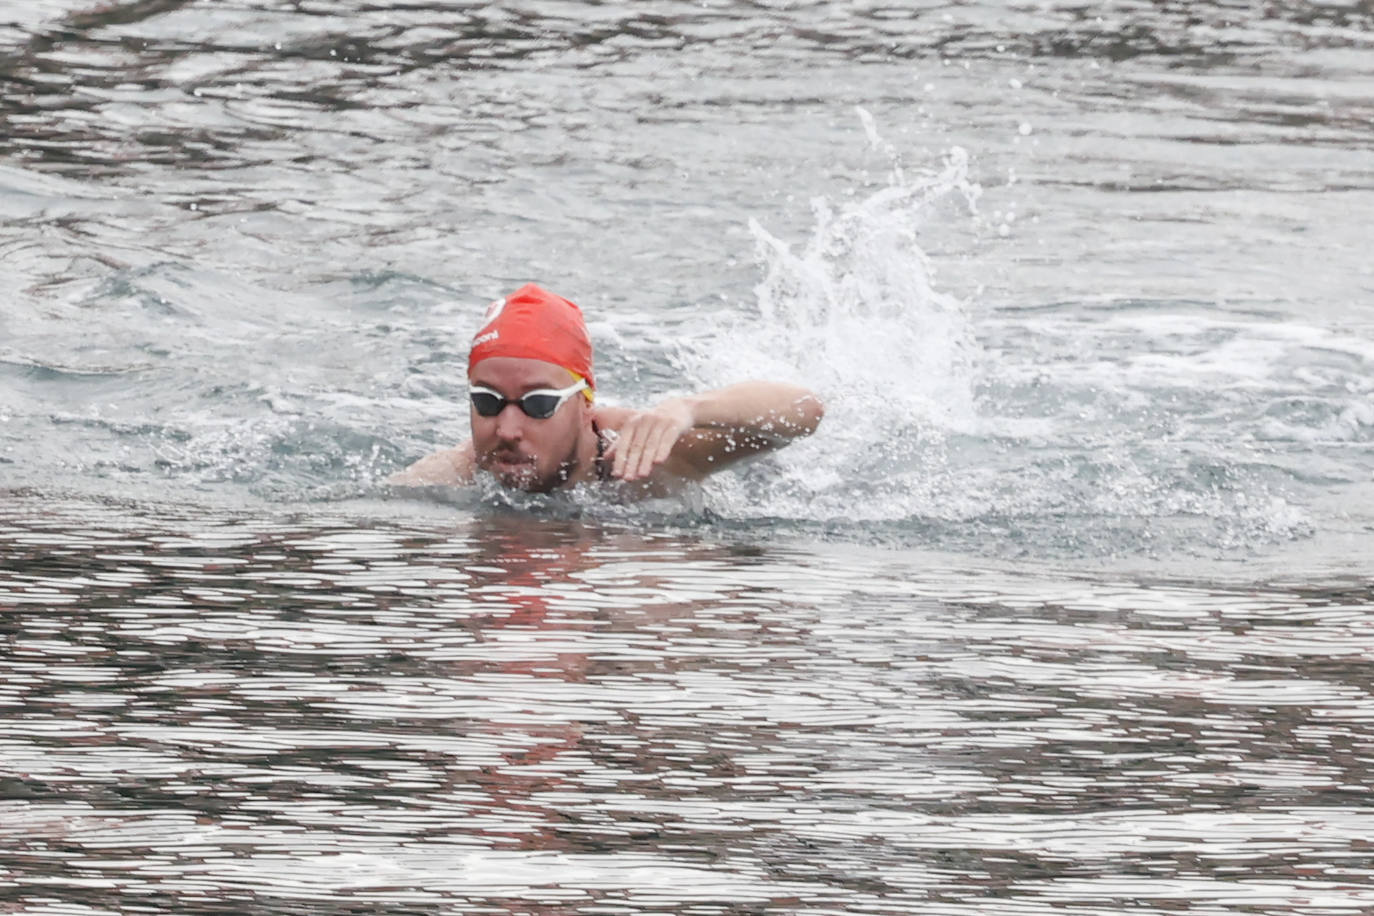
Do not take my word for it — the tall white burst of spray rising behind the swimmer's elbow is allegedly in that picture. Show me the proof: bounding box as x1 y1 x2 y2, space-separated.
682 133 978 448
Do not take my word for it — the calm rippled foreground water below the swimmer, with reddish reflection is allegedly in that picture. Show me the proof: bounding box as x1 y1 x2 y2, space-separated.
0 496 1374 913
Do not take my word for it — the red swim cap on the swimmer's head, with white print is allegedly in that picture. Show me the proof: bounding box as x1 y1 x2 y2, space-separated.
467 283 596 389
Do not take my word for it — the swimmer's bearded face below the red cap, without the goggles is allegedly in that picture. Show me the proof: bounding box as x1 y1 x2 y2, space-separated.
467 356 591 493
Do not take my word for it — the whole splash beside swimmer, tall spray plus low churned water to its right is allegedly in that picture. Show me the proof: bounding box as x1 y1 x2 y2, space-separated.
680 111 1311 556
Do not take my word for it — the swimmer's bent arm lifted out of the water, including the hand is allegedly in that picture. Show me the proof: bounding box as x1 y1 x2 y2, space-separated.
607 382 826 481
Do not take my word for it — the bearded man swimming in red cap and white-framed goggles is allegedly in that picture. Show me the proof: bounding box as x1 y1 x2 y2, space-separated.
387 283 824 496
